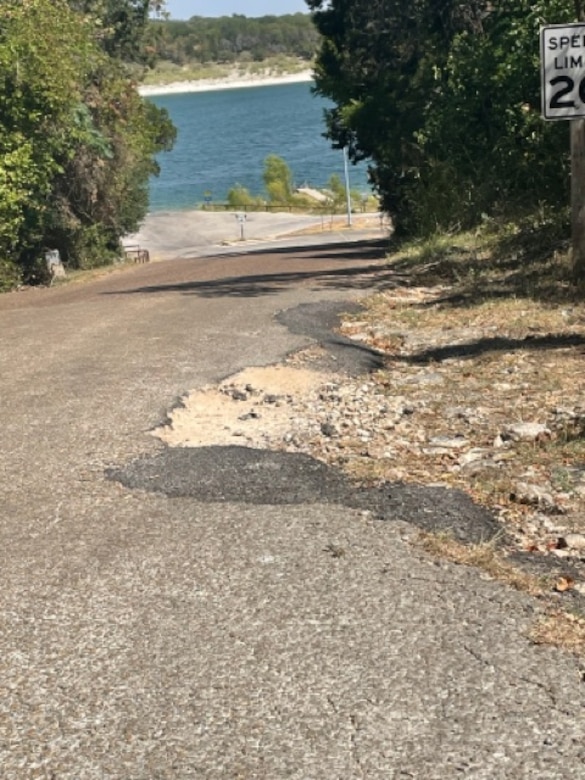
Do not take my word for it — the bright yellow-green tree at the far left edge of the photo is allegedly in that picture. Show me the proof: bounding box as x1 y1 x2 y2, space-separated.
0 0 98 282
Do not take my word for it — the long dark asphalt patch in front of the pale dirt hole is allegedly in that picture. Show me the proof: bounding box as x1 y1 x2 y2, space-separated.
106 446 500 544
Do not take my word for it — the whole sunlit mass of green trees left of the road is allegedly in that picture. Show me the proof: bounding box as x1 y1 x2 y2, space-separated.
0 0 174 287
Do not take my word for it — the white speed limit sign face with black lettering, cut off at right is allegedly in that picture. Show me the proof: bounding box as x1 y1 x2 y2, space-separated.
540 24 585 119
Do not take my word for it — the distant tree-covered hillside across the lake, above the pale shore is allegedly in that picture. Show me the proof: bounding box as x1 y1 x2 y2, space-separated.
151 13 319 67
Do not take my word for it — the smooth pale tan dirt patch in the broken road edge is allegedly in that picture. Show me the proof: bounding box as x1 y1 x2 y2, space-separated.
153 366 330 449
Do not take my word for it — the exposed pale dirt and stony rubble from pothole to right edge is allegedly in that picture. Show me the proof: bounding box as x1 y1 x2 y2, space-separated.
149 239 585 608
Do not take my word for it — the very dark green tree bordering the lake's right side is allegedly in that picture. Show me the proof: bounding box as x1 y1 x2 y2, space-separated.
308 0 458 230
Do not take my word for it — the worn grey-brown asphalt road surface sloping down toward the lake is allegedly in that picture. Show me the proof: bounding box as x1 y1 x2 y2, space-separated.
0 235 585 780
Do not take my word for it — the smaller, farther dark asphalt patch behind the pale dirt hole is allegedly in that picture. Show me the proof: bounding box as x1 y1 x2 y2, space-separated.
276 301 384 376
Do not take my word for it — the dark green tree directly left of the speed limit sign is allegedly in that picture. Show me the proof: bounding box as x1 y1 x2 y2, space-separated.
411 0 572 230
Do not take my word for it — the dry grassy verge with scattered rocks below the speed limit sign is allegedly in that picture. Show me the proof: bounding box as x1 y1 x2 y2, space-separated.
344 216 585 653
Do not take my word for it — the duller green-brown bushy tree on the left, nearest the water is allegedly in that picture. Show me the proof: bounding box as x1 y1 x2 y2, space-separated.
44 59 175 268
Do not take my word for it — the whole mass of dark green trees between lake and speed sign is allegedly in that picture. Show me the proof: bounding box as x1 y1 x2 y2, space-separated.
307 0 578 231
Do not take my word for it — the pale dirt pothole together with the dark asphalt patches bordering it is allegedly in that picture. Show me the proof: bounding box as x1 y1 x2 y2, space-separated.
107 304 500 543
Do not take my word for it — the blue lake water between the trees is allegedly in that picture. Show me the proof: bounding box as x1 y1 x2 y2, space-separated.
149 83 369 211
